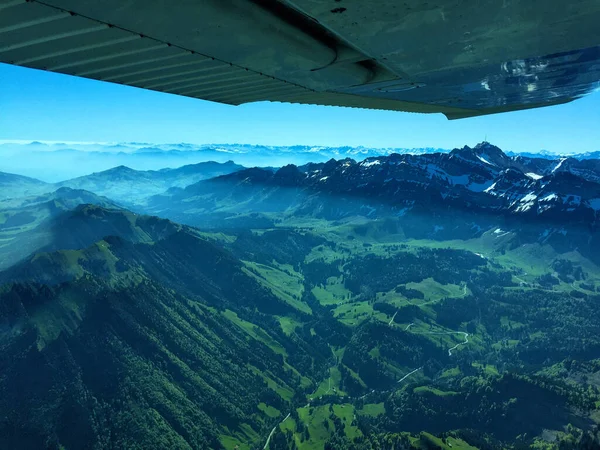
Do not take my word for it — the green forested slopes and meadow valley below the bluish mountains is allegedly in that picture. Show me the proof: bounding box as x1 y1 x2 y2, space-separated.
0 205 600 450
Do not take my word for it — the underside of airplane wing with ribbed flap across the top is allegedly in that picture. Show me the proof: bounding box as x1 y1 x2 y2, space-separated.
0 0 600 119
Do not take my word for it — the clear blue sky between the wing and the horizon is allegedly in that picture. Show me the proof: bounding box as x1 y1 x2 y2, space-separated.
0 64 600 153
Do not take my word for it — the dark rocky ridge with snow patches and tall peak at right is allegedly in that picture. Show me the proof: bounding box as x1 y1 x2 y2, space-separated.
147 143 600 232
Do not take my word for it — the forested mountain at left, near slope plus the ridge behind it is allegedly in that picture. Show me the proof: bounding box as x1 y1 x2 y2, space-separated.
0 222 326 448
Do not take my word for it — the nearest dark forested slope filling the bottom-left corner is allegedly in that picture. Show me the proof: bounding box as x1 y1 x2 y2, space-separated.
0 278 295 448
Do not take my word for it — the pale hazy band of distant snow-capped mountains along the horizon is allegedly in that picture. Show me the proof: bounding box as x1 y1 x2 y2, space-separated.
0 142 600 183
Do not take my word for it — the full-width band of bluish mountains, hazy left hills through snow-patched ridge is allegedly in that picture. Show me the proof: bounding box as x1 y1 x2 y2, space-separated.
0 142 600 264
